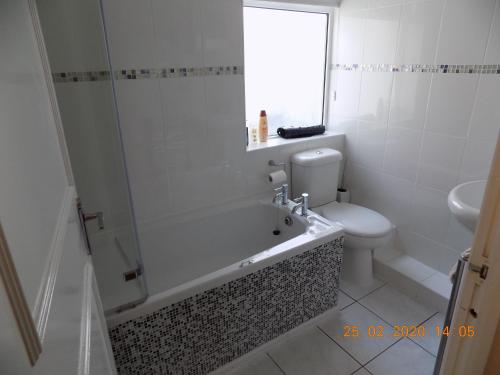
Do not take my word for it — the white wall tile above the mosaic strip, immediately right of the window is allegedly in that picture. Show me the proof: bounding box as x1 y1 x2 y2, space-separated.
335 7 367 64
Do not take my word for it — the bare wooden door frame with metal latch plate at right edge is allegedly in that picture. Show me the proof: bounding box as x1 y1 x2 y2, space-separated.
440 136 500 375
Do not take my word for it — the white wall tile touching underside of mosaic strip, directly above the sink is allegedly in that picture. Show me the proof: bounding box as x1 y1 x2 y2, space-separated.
426 74 478 137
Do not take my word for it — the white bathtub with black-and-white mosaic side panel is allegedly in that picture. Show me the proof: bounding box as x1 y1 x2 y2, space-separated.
108 201 343 375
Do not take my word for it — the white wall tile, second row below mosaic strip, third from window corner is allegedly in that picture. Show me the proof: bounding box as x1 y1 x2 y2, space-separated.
383 127 422 181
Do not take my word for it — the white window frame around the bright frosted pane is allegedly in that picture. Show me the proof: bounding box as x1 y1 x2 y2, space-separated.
242 0 335 133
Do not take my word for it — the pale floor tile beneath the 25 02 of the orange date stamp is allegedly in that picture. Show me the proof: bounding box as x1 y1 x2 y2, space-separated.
319 303 399 364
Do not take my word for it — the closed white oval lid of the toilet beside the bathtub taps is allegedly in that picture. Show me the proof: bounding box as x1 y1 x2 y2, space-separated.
320 202 392 237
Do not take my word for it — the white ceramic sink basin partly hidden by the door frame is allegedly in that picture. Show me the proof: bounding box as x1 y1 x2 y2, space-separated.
448 180 486 232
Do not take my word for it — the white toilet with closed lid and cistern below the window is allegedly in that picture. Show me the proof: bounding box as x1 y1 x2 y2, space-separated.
291 148 392 286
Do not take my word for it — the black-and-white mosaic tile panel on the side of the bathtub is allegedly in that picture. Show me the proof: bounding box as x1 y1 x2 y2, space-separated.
109 237 344 375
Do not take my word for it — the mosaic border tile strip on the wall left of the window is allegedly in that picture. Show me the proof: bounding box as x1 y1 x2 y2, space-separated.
52 66 243 83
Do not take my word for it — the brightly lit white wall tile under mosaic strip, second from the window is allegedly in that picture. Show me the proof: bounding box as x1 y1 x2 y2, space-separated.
358 72 393 123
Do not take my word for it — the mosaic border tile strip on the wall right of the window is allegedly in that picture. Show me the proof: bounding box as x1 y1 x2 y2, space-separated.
332 64 500 74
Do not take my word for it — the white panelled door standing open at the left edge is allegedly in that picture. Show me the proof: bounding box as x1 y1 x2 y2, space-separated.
0 0 115 375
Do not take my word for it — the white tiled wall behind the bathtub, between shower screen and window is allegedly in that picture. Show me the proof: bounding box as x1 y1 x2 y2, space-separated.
103 0 343 292
